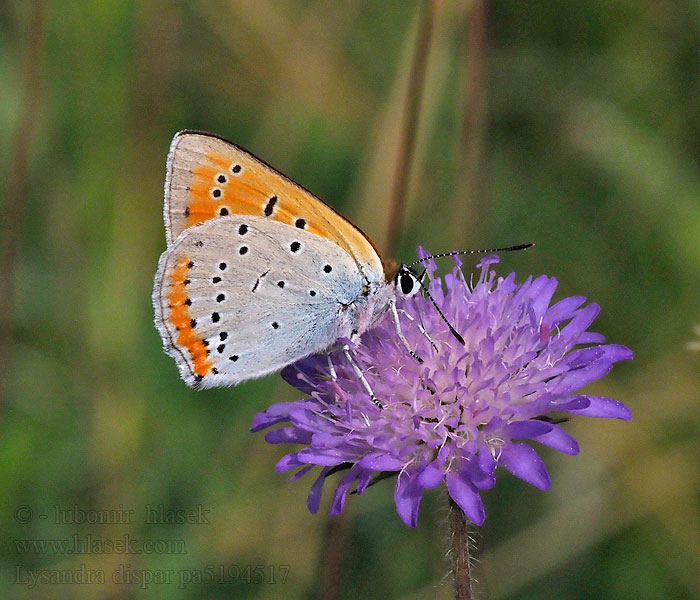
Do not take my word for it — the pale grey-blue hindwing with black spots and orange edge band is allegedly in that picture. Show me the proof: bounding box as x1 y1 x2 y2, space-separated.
153 215 363 387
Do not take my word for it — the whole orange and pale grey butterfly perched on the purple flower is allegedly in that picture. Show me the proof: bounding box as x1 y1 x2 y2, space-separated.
153 131 422 388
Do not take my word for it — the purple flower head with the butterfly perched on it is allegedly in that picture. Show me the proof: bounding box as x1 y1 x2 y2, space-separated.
252 249 632 526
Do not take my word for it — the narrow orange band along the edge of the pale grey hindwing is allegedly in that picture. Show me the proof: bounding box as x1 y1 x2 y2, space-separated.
168 256 211 377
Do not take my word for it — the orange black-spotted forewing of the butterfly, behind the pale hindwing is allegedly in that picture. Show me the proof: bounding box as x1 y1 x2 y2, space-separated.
165 131 382 274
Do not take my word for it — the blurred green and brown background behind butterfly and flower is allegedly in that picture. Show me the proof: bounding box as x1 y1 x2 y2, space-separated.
0 0 700 599
